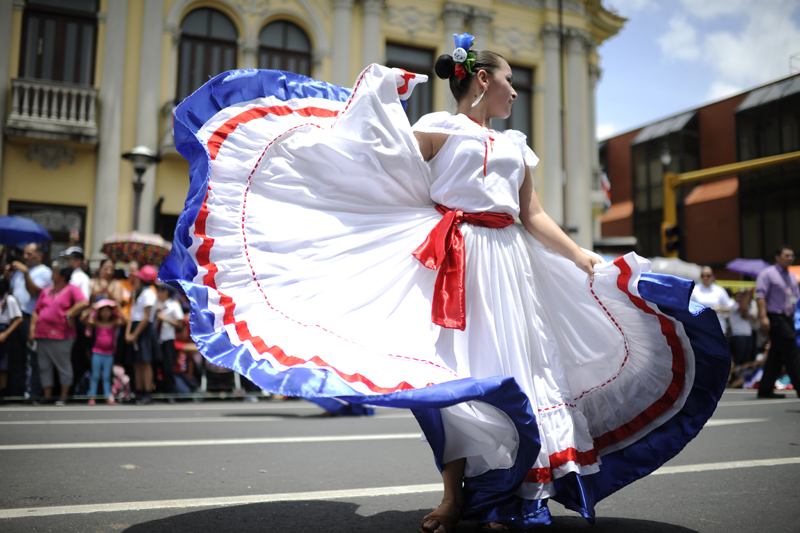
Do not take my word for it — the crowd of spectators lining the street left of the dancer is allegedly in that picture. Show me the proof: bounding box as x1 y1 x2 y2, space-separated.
0 243 214 405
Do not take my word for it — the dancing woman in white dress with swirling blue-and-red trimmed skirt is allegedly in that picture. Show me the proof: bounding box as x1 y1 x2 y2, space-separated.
161 34 729 533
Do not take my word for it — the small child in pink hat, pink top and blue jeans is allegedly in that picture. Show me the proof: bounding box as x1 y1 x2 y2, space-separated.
84 298 125 405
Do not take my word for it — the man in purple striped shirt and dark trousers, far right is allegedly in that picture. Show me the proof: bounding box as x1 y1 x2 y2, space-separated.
756 245 800 398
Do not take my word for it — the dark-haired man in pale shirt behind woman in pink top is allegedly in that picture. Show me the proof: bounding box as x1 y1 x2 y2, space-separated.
7 242 53 397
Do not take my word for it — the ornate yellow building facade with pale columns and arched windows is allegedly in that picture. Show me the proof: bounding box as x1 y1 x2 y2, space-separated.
0 0 624 258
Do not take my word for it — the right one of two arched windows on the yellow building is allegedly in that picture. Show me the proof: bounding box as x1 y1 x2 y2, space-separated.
258 20 311 76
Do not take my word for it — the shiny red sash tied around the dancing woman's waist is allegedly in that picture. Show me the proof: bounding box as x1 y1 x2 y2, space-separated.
412 205 514 331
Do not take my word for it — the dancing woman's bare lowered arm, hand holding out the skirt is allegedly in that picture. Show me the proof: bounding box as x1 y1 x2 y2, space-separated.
519 165 601 280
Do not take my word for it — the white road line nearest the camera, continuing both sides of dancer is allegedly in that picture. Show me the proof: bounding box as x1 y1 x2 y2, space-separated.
6 457 800 520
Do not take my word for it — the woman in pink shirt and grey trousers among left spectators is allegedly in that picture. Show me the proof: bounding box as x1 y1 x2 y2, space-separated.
28 267 89 405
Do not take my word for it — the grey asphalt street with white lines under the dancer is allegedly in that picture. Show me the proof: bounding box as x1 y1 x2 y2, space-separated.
0 391 800 533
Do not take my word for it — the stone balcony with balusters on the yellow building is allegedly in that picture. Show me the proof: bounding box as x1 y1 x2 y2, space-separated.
4 78 98 145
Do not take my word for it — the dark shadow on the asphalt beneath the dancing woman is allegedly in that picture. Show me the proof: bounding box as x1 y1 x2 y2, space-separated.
125 501 696 533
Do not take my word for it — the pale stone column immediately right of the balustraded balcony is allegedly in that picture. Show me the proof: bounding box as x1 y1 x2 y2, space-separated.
92 0 129 255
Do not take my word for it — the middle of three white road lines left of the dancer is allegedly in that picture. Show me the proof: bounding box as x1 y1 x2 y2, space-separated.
0 432 420 451
